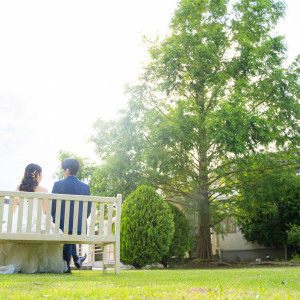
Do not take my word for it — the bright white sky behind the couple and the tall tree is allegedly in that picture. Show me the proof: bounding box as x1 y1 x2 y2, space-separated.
0 0 300 192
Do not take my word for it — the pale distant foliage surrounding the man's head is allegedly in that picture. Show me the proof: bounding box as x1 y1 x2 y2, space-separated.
53 150 95 183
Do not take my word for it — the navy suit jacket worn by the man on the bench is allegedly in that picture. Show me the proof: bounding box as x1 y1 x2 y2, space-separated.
51 176 92 234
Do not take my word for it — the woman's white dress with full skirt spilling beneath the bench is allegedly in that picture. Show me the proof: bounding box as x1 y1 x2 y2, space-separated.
0 199 67 274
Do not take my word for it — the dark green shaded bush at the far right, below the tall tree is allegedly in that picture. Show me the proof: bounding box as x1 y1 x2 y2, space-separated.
237 168 300 247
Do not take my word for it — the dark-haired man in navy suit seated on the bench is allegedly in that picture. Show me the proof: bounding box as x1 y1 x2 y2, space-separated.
51 158 91 273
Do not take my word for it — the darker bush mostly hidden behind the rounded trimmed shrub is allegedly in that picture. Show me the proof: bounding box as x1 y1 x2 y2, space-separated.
161 204 191 267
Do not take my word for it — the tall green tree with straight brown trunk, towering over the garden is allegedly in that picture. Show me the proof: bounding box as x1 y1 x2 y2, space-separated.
94 0 299 258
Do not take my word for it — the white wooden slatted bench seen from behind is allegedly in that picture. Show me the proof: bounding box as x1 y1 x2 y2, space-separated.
0 191 122 274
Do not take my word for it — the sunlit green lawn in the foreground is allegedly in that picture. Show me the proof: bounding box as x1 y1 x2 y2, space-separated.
0 267 300 299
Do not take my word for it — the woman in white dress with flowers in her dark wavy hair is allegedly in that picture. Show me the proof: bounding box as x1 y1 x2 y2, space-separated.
0 164 67 274
